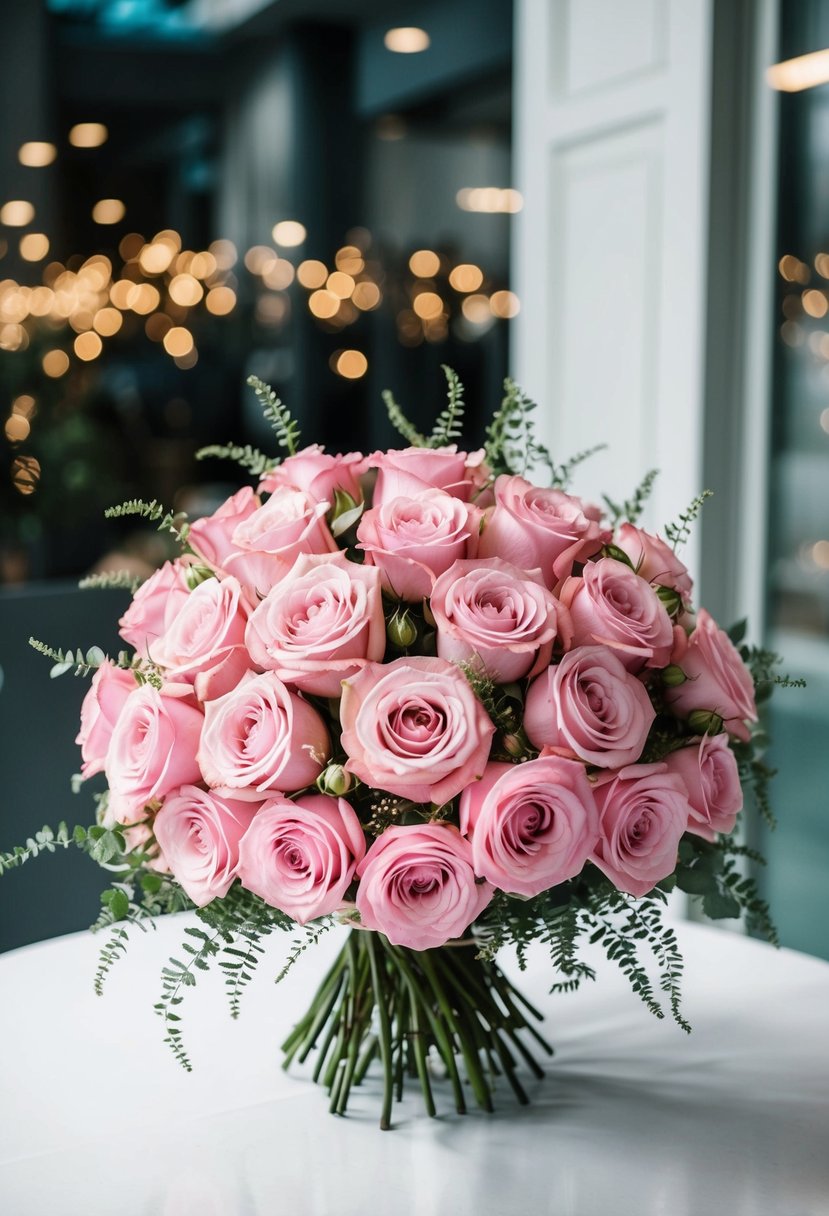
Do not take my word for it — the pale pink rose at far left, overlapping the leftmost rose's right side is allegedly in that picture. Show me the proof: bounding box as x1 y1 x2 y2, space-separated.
105 685 204 823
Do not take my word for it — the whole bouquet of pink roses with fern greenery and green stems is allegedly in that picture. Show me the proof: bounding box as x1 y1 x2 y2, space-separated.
12 370 787 1126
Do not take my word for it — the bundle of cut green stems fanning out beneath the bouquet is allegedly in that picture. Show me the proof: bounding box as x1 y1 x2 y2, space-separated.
282 929 552 1130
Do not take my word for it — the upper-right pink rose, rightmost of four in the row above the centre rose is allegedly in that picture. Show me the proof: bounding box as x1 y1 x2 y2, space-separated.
559 557 673 671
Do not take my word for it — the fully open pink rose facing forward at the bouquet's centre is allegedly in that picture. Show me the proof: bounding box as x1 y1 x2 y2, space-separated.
340 658 495 806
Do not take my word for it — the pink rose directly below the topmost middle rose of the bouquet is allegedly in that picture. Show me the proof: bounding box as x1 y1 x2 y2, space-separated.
357 490 480 601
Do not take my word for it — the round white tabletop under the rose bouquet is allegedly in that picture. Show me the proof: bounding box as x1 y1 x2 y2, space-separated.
0 917 829 1216
